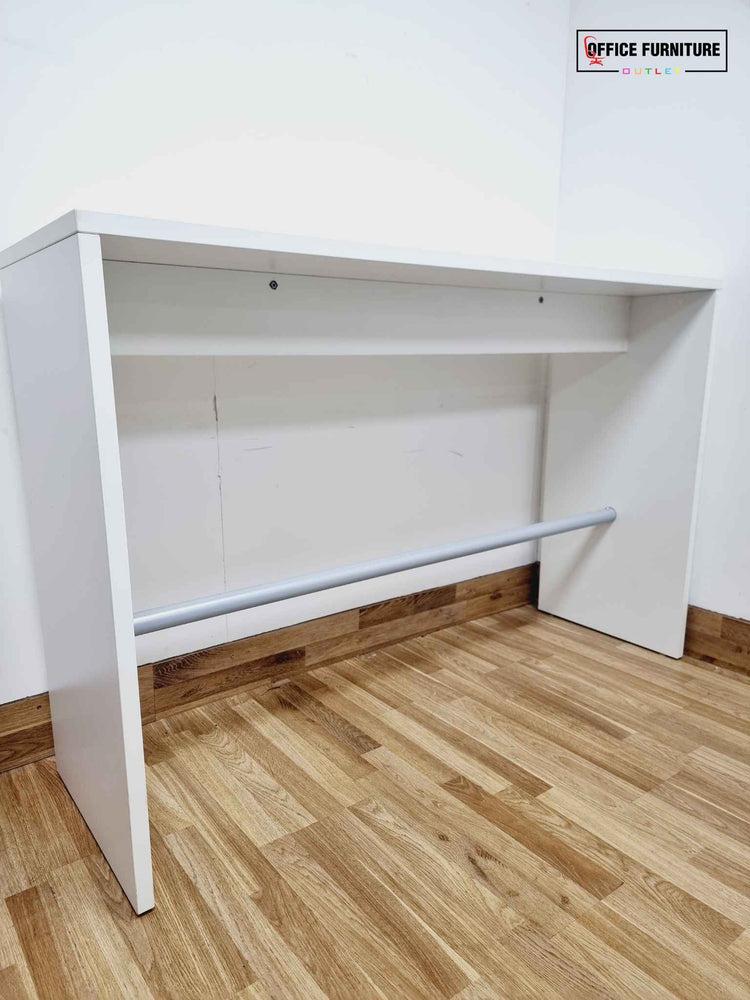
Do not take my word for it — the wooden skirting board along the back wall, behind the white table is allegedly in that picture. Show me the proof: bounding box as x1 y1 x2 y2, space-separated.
0 563 538 772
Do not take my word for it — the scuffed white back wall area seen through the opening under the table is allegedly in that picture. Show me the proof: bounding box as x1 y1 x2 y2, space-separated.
114 355 545 663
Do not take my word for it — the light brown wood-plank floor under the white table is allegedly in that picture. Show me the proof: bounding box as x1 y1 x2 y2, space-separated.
0 608 750 1000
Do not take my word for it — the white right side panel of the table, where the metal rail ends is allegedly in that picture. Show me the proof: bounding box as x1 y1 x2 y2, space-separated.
539 292 714 657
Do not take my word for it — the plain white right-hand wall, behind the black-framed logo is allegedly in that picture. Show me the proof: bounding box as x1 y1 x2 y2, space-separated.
557 0 750 618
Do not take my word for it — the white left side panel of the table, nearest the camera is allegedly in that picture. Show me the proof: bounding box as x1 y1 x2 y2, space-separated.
2 235 153 913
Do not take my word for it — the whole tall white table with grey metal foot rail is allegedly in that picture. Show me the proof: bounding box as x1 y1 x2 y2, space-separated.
0 212 717 913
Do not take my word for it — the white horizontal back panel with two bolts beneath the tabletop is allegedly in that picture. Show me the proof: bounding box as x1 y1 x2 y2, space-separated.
104 261 632 356
